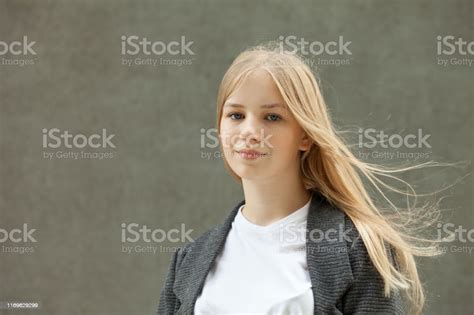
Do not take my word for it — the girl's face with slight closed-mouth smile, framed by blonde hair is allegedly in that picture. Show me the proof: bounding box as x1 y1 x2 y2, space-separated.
220 70 310 179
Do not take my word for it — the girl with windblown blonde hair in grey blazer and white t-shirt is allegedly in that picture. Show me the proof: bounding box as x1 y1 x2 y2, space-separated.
158 45 439 314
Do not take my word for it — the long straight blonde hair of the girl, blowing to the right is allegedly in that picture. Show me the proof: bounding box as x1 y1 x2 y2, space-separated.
216 43 452 314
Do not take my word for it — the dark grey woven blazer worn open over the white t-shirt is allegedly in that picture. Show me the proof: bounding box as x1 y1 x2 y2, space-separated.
157 192 405 314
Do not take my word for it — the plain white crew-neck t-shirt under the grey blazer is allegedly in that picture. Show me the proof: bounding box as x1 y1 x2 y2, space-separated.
194 200 314 315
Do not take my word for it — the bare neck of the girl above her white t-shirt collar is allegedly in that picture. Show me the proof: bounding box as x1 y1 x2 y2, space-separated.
242 174 311 225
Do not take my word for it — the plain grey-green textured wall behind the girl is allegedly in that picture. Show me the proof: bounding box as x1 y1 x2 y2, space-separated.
0 0 474 314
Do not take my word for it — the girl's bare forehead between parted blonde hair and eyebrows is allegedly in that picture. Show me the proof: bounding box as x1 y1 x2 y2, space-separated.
226 69 285 108
